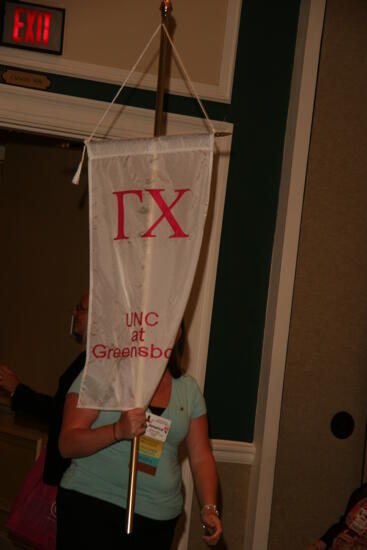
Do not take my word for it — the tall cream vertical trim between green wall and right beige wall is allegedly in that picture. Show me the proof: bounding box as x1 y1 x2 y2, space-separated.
244 0 326 550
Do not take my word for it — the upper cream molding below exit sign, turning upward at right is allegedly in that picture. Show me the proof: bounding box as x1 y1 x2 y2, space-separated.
0 0 242 103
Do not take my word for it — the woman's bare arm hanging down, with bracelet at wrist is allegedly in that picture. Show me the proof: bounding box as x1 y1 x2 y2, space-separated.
186 414 223 544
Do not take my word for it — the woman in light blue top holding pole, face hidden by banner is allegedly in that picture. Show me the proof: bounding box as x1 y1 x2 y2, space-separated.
57 330 222 550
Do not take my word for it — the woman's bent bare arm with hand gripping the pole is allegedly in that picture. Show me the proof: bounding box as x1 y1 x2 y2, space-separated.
59 393 146 458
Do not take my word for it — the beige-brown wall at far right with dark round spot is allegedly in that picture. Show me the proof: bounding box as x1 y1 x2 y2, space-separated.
269 0 367 550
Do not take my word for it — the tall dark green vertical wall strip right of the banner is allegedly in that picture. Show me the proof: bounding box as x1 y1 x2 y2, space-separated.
205 0 299 441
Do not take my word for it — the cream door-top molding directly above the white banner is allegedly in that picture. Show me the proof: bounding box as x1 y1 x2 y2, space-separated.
0 84 233 140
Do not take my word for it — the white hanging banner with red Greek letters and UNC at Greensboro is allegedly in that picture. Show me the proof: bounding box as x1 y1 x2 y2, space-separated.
79 134 214 410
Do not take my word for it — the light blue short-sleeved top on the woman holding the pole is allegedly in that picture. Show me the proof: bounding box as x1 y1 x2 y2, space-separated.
60 373 206 520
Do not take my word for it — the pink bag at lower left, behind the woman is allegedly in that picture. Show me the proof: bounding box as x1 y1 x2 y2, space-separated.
6 449 57 550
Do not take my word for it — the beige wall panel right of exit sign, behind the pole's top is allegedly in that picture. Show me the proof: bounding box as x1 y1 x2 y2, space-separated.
58 0 228 84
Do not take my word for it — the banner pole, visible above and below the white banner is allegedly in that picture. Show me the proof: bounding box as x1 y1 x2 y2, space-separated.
125 0 172 535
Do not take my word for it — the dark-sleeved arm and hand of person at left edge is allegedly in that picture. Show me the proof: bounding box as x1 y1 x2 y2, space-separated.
0 365 54 422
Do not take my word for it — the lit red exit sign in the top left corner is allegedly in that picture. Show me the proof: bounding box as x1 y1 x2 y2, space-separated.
0 0 65 55
